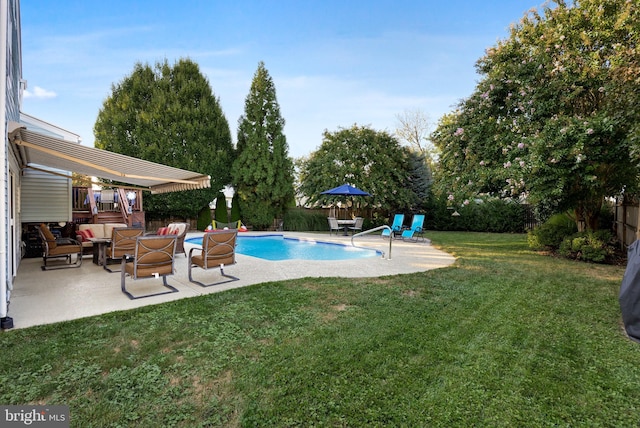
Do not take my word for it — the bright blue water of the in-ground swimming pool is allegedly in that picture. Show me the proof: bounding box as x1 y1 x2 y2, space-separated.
186 235 382 261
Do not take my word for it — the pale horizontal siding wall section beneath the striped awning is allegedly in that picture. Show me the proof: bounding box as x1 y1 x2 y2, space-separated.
20 168 73 223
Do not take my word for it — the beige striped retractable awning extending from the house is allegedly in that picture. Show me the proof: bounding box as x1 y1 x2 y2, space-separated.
9 122 211 193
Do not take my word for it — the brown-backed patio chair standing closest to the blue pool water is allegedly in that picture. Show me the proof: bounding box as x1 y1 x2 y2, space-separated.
187 229 239 287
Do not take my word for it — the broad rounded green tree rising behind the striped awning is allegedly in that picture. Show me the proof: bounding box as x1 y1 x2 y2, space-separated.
94 59 234 218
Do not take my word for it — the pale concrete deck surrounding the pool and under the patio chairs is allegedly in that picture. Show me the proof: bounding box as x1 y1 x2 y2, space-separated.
8 232 455 329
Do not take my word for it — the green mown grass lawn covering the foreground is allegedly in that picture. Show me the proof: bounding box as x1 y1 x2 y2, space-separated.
0 232 640 427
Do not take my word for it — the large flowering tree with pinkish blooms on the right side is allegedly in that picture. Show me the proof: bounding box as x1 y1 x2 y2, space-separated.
432 0 640 229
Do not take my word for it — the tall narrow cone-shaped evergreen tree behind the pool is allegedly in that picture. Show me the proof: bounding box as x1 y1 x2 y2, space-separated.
233 62 294 229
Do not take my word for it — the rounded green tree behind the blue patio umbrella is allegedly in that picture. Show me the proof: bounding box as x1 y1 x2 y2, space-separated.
299 125 416 214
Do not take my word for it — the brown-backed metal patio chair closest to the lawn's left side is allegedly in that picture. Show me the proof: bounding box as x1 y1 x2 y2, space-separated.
120 235 178 300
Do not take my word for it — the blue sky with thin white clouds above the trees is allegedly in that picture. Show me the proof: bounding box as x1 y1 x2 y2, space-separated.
21 0 542 157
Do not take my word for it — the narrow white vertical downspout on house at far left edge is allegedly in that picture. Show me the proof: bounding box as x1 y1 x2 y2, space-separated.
0 0 9 325
